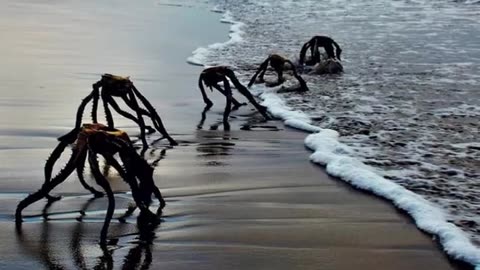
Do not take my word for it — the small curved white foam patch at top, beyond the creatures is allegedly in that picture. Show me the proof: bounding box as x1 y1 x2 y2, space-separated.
187 9 245 66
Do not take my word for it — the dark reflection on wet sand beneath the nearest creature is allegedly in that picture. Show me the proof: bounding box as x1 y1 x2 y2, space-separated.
17 198 159 269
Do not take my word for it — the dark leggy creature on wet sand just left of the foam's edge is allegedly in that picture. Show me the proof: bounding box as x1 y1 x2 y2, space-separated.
198 66 271 127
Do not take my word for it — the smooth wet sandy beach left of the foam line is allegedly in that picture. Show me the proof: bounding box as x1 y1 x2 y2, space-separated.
0 1 469 270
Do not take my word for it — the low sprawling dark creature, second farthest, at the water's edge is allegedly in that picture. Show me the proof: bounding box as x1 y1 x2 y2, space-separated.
248 54 308 91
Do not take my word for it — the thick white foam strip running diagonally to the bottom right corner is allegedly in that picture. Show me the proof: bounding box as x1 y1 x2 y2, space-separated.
255 84 480 270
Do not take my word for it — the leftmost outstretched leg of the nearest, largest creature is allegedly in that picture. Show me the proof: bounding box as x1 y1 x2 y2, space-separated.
15 151 77 223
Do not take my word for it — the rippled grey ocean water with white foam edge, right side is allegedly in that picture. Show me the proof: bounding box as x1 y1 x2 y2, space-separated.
188 0 480 265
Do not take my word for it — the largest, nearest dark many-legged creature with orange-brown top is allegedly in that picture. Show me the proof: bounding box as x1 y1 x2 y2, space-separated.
15 123 165 244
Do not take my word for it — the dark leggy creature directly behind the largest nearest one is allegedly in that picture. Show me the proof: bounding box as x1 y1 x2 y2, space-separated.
75 74 177 148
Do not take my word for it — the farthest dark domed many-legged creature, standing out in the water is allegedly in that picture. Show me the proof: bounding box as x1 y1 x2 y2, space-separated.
299 36 342 66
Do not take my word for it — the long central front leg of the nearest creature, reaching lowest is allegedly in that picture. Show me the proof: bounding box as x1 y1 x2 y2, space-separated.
88 150 115 245
